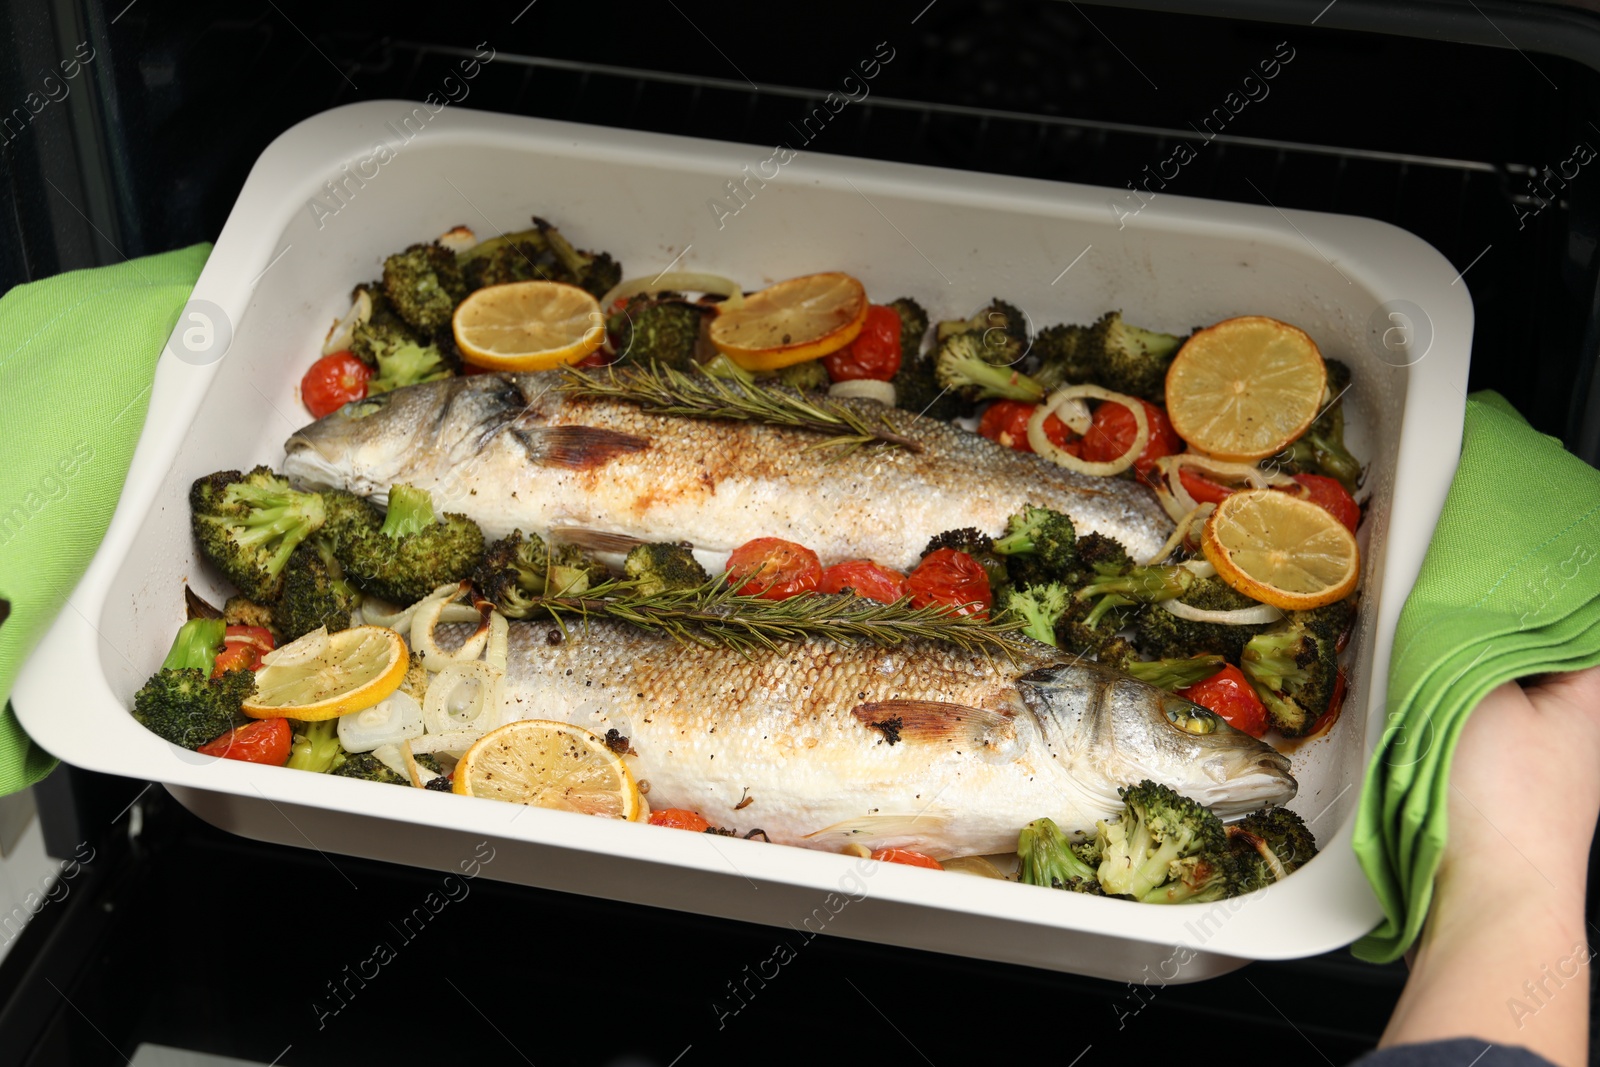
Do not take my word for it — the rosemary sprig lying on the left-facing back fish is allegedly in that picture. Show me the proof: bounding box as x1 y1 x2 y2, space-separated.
560 363 922 453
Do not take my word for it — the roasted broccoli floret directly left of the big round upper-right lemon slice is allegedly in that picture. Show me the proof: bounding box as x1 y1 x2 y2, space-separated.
1035 312 1184 403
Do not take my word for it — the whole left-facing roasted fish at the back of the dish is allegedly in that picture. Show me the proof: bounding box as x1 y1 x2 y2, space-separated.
285 373 1173 569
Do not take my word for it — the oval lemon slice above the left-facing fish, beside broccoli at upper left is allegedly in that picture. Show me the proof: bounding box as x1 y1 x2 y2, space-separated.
450 282 605 371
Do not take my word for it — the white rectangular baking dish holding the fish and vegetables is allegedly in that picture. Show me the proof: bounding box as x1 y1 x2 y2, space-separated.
14 101 1472 981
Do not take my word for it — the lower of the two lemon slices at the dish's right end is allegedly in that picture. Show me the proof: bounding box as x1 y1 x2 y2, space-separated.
1200 490 1362 611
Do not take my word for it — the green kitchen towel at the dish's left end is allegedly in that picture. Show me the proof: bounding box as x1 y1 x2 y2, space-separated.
0 245 211 795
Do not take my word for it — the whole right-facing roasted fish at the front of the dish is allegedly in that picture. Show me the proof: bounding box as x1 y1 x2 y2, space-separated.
502 621 1296 859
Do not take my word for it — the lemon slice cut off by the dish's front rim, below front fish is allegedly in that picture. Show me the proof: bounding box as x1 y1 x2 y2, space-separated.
454 718 650 821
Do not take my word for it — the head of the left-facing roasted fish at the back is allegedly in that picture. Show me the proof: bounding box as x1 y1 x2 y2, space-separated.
283 374 544 506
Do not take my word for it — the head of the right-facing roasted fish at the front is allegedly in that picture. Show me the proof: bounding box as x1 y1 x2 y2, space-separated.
1018 664 1299 817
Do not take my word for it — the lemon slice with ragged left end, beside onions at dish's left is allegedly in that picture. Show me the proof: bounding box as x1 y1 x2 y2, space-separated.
243 625 410 721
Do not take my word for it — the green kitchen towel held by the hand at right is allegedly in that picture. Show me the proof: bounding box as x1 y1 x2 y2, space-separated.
1352 392 1600 963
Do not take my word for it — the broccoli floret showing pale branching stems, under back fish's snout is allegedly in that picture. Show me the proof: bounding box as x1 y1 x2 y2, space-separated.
189 467 325 601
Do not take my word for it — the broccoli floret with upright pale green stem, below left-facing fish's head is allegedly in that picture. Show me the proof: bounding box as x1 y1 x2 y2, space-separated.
334 485 483 605
